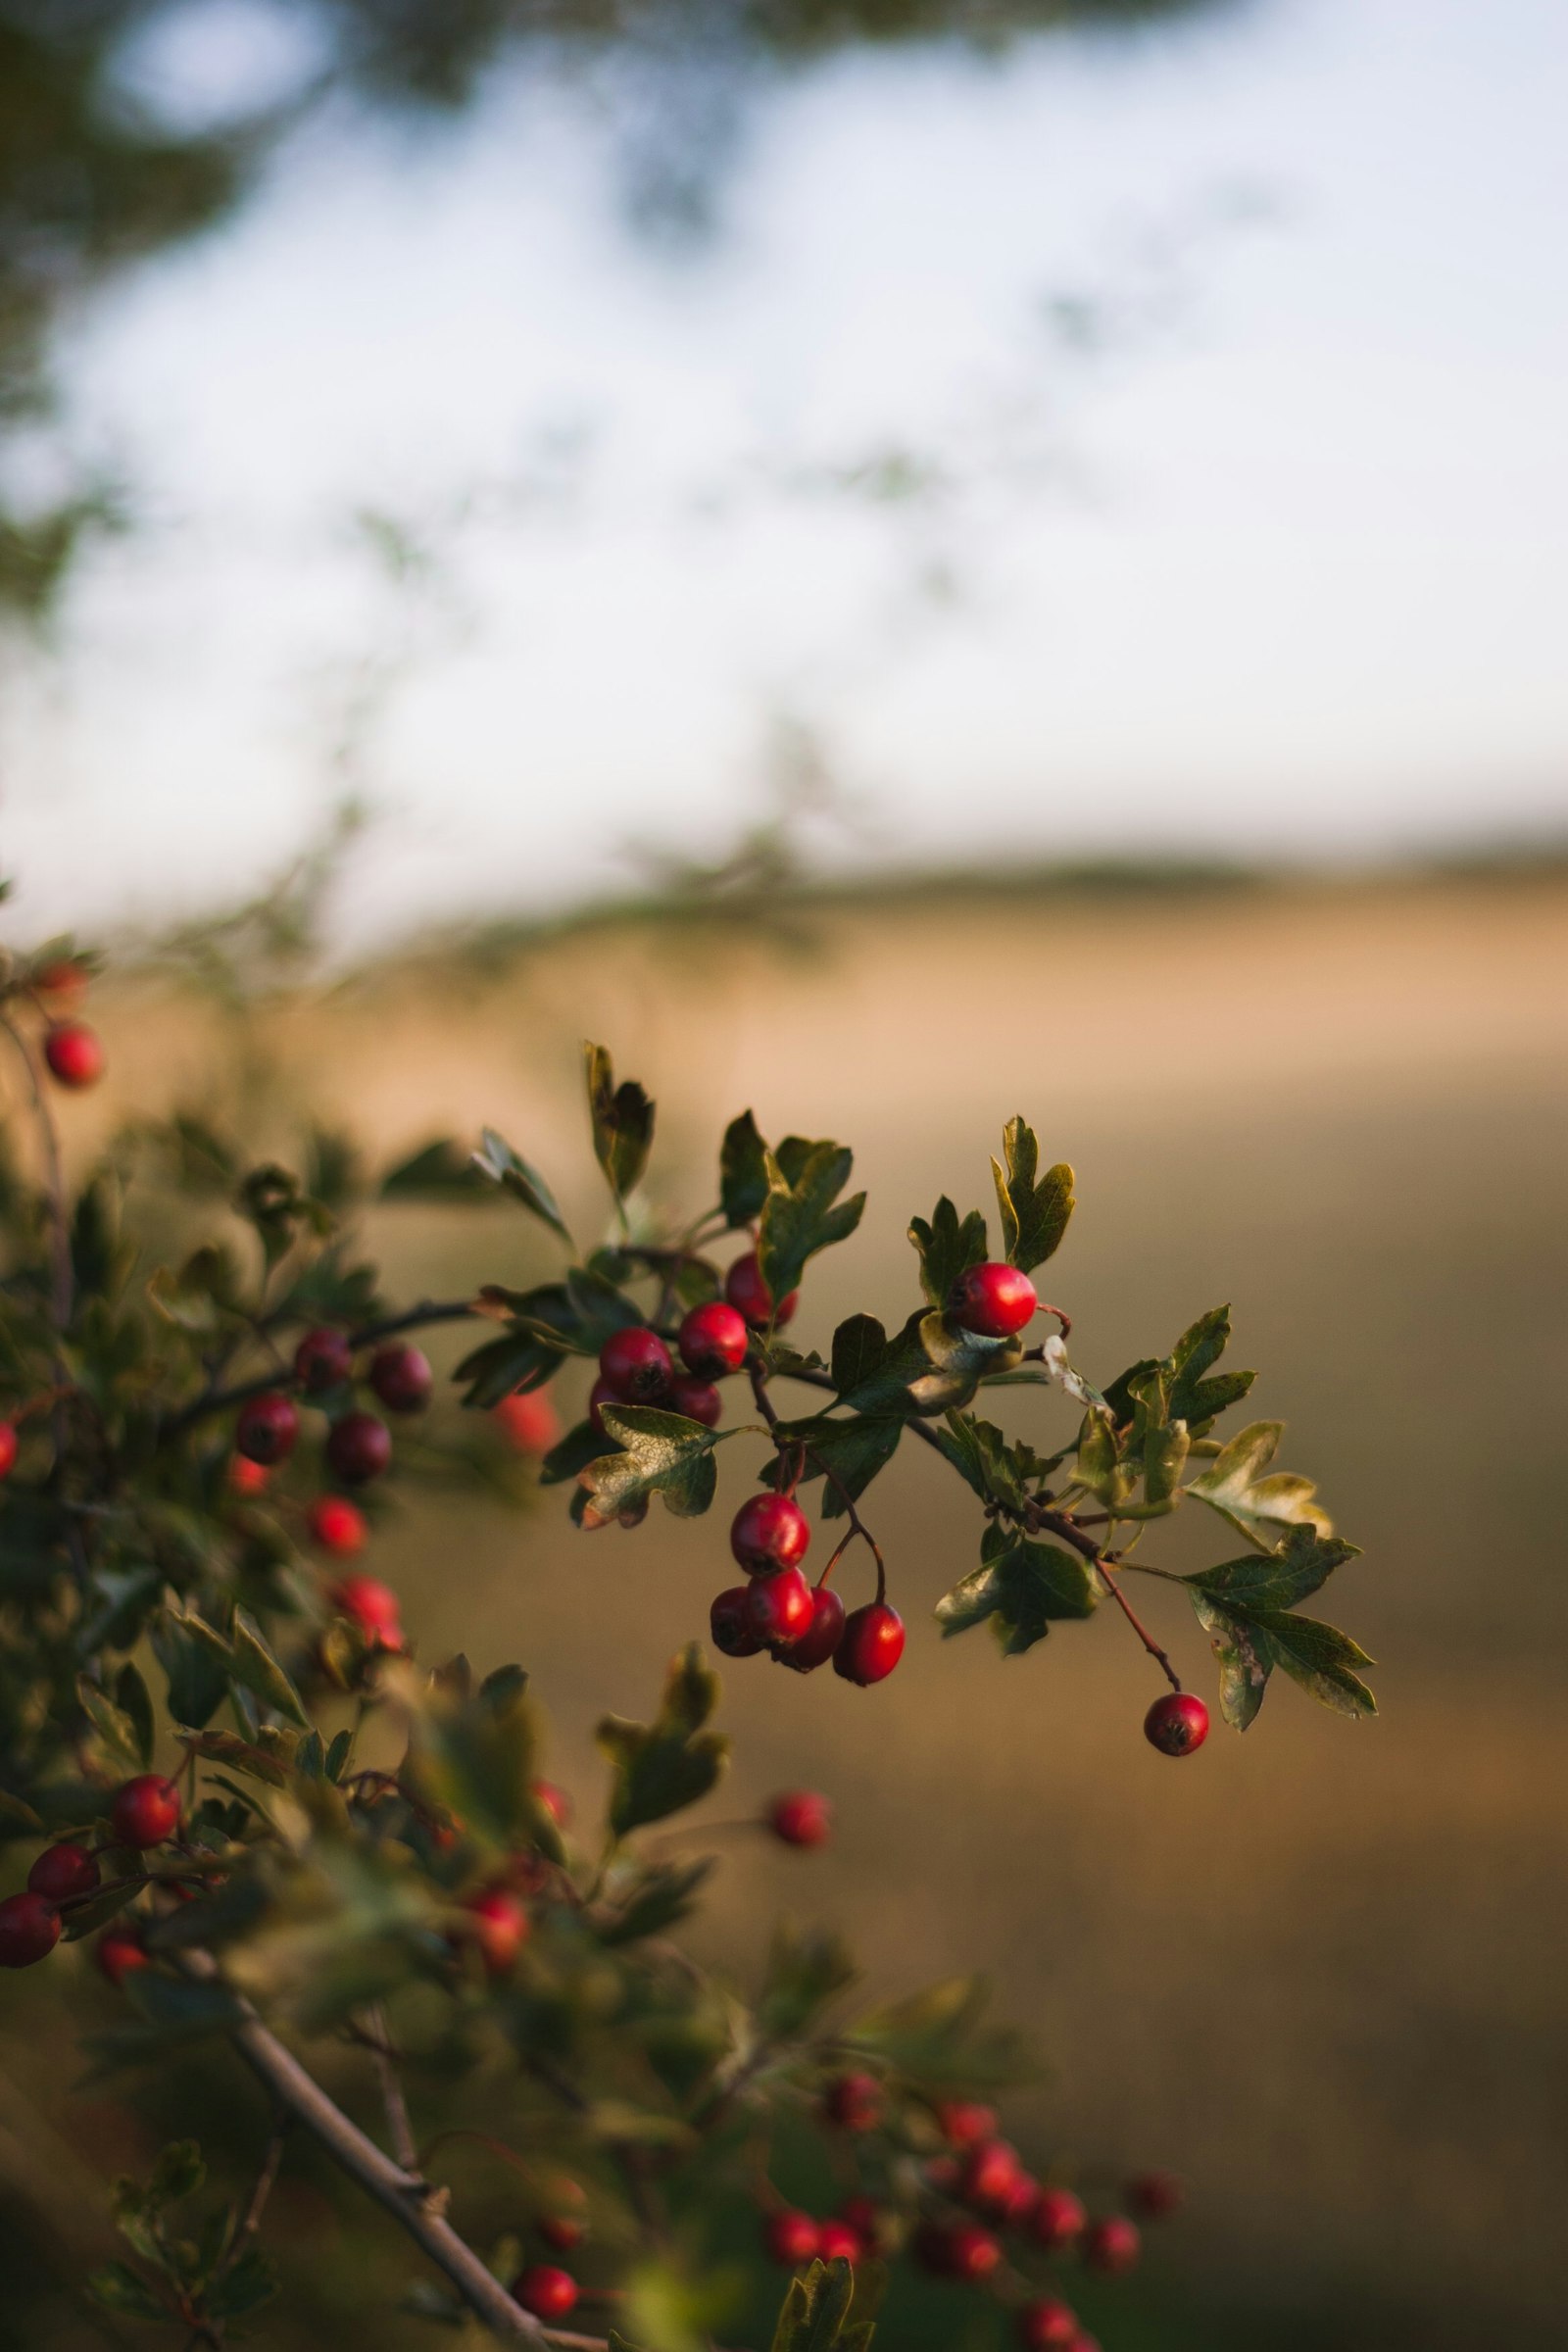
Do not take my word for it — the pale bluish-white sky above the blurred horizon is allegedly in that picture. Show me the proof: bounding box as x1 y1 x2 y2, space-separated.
0 0 1568 939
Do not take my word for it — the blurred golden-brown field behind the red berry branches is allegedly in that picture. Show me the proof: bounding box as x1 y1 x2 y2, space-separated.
0 880 1568 2352
